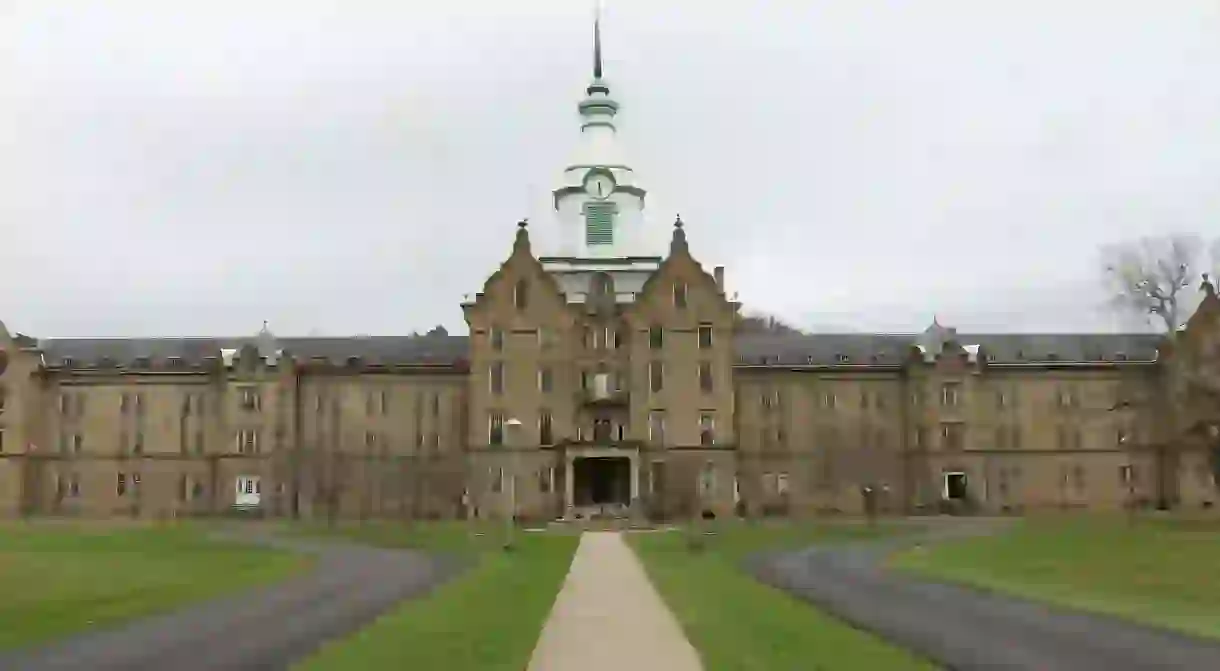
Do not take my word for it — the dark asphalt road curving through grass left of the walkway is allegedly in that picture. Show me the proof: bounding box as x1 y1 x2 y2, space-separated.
0 532 460 671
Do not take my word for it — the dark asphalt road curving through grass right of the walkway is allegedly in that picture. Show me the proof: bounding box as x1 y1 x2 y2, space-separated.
747 529 1220 671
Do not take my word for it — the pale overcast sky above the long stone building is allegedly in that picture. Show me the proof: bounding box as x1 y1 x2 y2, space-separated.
0 0 1220 337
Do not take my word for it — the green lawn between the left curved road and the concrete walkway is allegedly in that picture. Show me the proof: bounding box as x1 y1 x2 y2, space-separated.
299 522 580 671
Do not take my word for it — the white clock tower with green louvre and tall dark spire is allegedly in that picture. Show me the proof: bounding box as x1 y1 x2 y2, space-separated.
553 11 649 259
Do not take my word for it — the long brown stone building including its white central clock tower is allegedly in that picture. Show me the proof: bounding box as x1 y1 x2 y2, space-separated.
0 21 1220 519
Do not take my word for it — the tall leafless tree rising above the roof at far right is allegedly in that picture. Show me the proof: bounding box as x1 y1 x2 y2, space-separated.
1102 235 1220 336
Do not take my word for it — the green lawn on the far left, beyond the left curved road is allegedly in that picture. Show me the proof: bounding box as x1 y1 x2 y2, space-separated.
0 523 309 649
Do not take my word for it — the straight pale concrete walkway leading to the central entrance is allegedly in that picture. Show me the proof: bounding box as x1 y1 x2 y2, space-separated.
529 532 703 671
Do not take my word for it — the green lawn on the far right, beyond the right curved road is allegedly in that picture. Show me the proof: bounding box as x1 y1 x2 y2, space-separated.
892 516 1220 638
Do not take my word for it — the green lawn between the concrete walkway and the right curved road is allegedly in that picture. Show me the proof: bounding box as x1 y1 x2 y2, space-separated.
628 523 935 671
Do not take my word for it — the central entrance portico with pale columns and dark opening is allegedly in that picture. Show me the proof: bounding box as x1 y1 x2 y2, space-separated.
564 445 639 517
